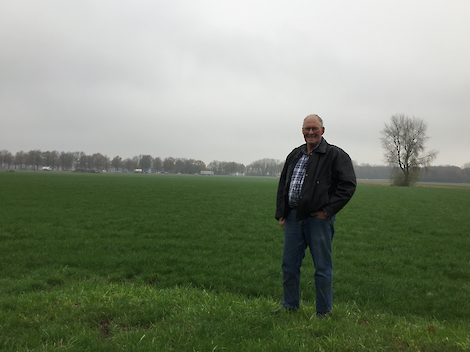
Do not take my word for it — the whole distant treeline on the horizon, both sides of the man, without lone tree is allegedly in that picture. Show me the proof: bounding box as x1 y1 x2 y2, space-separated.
0 149 470 183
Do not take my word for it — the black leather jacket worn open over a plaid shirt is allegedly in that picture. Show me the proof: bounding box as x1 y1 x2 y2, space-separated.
276 139 356 220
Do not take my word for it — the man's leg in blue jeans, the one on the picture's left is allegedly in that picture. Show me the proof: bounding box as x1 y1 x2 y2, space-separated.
282 210 306 309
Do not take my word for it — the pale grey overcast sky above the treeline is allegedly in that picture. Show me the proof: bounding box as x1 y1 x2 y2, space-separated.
0 0 470 166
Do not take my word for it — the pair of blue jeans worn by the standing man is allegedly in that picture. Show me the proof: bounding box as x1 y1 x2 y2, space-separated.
282 209 335 312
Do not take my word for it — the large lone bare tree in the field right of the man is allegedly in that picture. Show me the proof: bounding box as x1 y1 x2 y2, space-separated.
381 114 438 186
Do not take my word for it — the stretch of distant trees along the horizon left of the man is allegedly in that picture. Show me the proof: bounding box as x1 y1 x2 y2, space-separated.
0 149 283 176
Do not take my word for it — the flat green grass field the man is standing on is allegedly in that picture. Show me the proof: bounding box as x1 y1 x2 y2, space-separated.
0 172 470 351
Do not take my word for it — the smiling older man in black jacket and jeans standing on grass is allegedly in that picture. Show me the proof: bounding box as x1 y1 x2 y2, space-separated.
273 115 356 319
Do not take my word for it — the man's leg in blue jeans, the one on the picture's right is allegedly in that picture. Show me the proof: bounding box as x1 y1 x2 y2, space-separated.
304 216 334 313
